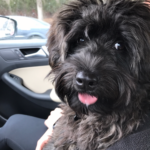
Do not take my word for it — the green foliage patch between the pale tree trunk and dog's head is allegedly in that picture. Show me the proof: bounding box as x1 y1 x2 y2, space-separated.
43 0 69 14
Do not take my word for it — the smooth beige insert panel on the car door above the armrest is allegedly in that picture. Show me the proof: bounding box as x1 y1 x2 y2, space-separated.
9 65 53 93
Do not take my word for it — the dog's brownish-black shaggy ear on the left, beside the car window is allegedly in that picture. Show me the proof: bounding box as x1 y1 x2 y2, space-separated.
47 2 81 68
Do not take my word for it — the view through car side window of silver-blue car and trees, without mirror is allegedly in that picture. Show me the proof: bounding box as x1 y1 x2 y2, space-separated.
0 0 69 40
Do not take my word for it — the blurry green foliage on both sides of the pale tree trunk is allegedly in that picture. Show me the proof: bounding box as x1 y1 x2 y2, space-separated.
0 0 70 17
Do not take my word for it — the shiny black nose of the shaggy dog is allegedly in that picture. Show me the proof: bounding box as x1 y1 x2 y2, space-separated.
76 72 98 90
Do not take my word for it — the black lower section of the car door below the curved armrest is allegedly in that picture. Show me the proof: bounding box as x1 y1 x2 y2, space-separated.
0 80 52 120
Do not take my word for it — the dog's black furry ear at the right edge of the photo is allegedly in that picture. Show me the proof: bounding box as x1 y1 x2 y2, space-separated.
127 0 150 79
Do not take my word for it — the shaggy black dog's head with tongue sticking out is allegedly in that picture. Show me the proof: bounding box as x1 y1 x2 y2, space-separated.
48 0 150 114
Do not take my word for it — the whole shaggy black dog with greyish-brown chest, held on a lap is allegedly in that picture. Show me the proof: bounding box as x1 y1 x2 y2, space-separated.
42 0 150 150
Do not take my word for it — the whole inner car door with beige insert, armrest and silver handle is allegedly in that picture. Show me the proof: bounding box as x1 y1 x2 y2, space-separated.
0 16 60 127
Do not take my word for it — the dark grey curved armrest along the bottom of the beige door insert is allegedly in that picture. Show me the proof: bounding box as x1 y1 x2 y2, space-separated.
2 73 59 109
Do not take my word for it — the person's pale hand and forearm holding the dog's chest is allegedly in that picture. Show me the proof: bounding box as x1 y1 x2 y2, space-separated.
36 108 62 150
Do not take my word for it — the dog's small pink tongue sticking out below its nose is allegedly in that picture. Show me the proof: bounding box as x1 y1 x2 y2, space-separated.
78 93 97 105
